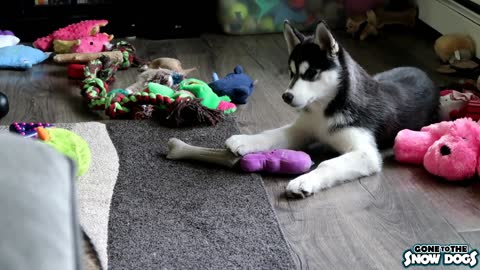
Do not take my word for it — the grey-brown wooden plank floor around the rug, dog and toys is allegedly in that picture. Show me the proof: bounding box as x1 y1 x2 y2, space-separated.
0 24 480 269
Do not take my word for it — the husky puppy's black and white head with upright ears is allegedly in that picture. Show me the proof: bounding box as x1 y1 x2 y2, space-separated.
282 21 340 109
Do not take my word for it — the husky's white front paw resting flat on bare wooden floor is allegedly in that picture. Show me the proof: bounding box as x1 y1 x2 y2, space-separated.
286 173 321 198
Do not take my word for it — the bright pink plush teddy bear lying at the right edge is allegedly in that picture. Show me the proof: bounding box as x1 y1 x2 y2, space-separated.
393 118 480 181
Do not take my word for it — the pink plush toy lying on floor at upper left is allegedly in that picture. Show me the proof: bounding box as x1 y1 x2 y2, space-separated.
33 20 113 53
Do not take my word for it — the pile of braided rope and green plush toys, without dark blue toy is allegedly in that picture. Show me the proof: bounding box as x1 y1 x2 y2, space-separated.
81 53 237 127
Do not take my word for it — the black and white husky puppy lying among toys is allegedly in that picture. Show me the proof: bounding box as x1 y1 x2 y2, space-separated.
226 21 439 197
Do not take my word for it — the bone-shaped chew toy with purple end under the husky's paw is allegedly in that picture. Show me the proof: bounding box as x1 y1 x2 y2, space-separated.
167 138 313 174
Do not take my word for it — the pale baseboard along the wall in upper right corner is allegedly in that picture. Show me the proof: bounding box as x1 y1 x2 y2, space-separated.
417 0 480 58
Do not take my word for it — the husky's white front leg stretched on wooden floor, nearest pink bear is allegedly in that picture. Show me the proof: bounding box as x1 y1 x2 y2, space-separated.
286 128 382 197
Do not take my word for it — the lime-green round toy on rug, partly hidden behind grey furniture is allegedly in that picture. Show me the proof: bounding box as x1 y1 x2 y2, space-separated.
37 127 92 176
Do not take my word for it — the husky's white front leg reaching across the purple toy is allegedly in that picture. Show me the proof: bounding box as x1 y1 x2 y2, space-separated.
225 122 311 156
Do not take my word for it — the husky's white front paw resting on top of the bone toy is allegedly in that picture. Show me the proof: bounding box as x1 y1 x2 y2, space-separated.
225 134 269 156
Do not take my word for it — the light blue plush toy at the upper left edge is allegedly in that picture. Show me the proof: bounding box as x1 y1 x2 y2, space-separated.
0 45 50 69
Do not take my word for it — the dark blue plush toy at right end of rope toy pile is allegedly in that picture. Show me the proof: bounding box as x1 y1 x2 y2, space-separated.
209 65 254 104
